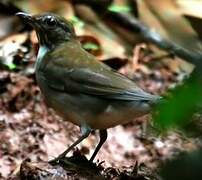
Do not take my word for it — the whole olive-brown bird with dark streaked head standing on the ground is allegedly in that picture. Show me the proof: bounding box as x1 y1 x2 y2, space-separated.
16 12 161 163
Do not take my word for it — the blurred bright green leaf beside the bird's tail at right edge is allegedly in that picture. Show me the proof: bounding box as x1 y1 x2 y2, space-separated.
154 73 202 130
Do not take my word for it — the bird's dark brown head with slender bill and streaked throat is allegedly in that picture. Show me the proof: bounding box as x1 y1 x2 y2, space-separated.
16 12 76 49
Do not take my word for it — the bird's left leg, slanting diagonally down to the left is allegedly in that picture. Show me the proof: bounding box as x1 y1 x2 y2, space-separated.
49 126 92 163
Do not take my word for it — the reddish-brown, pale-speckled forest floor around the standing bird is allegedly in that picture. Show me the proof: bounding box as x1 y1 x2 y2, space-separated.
0 30 200 179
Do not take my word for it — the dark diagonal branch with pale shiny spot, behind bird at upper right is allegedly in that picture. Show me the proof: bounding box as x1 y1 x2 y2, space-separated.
107 11 202 70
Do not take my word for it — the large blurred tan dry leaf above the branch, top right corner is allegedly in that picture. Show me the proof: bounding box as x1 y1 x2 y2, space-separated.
138 0 202 53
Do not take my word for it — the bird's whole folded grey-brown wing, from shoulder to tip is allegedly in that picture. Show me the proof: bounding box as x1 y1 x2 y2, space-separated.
43 61 157 101
